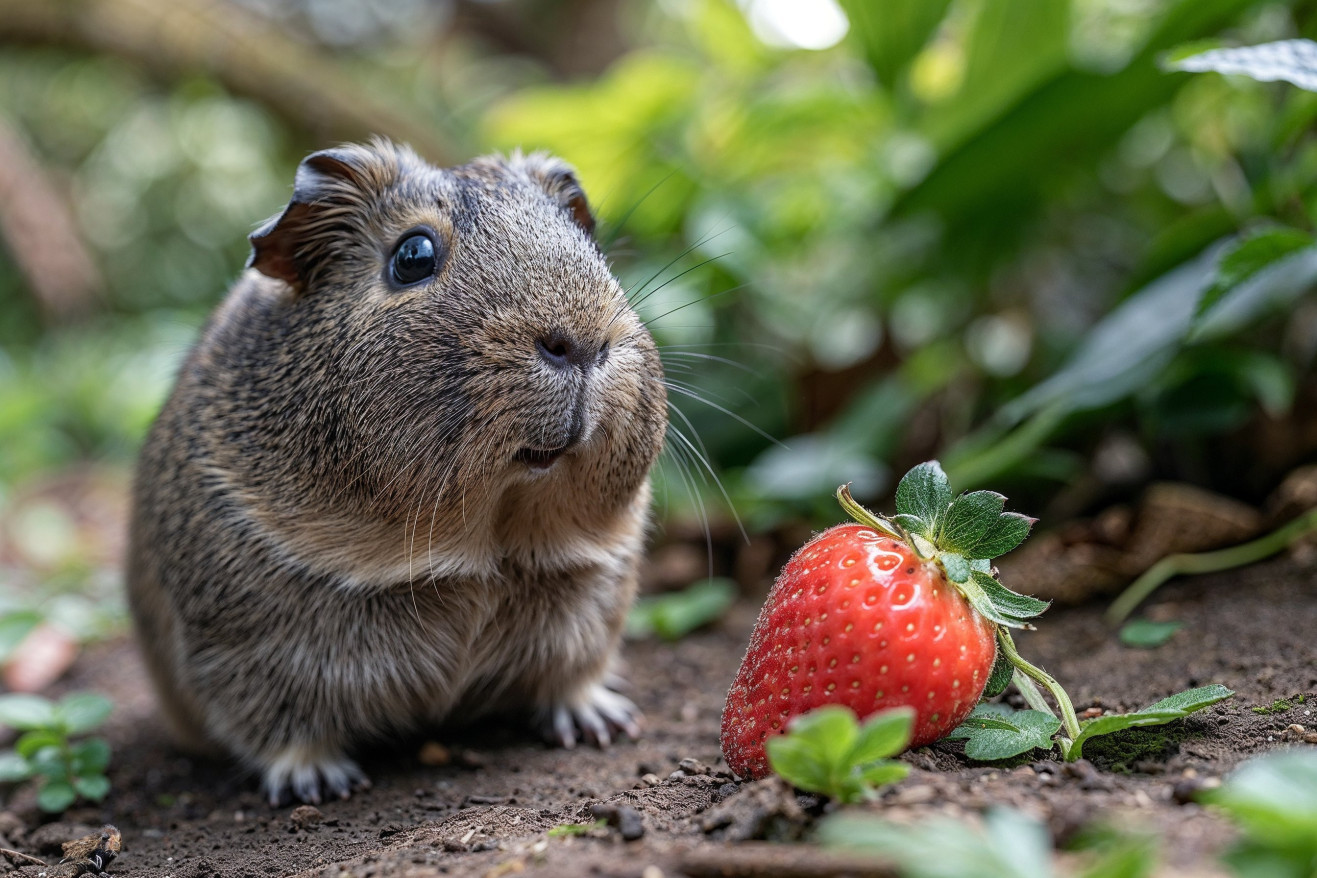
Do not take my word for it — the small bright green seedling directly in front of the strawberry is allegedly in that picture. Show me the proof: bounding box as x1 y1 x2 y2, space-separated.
766 704 914 803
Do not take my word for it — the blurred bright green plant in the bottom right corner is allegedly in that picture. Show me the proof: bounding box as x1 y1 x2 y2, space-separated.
1198 750 1317 878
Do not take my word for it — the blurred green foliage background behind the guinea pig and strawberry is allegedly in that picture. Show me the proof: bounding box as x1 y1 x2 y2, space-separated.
0 0 1317 616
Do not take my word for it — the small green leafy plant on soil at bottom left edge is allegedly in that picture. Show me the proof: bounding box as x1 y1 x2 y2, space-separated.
0 692 113 813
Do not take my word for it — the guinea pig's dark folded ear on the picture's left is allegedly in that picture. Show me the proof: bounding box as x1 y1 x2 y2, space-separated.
248 146 365 288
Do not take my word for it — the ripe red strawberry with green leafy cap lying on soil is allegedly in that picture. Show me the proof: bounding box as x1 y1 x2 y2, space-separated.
722 461 1047 778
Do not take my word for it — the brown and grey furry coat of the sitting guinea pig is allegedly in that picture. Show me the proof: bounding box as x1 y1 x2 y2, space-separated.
128 141 666 800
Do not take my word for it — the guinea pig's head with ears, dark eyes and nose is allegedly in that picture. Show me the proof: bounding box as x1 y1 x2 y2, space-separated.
241 141 666 571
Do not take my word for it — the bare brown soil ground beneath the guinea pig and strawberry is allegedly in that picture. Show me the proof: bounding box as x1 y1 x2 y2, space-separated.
0 553 1317 878
